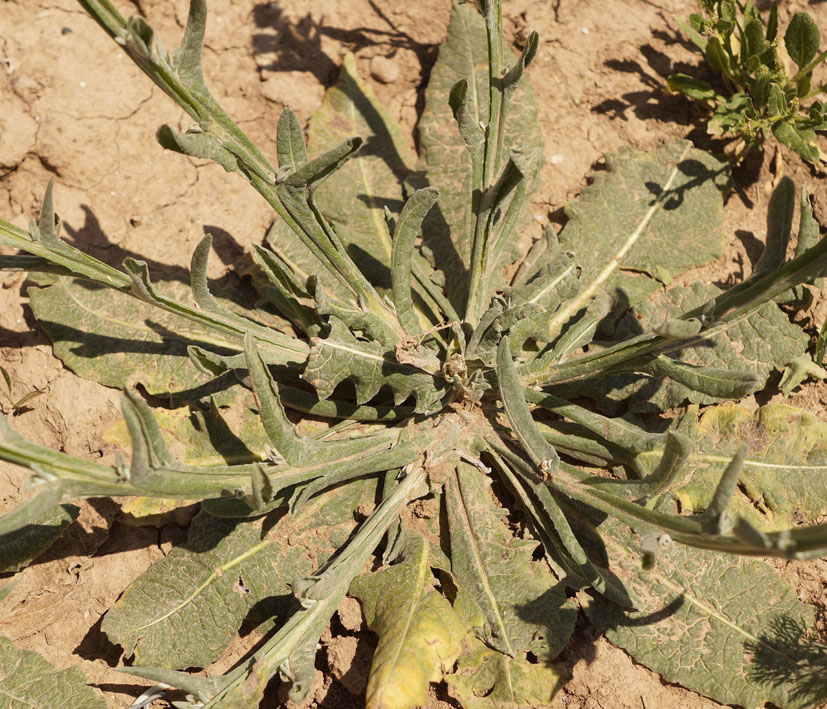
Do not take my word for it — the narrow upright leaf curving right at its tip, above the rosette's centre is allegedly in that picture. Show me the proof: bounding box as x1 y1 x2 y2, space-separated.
391 187 439 335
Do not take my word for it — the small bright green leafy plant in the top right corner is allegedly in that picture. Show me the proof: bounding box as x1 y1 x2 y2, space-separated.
669 0 827 163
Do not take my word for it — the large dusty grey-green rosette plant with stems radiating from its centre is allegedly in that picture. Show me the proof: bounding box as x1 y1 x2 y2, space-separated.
0 0 827 709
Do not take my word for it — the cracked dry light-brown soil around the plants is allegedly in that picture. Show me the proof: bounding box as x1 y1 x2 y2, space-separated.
0 0 827 709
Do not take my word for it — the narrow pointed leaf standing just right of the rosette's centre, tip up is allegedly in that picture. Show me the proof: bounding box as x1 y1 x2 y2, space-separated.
497 337 560 475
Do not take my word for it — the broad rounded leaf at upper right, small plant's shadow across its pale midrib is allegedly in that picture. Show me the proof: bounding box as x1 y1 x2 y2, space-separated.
560 140 728 306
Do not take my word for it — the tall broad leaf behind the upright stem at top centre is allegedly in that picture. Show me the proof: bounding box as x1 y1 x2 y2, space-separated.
417 3 543 296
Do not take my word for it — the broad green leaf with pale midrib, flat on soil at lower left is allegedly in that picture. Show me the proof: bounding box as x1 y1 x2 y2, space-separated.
101 479 375 669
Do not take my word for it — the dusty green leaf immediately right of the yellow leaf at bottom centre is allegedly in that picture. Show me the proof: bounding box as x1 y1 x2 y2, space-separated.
445 464 575 661
